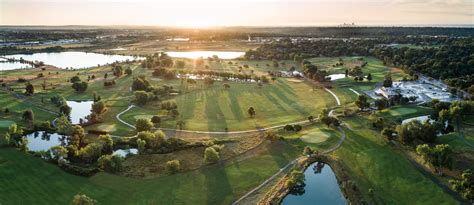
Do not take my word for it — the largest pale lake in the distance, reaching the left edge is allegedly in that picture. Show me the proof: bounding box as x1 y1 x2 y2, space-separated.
4 51 142 68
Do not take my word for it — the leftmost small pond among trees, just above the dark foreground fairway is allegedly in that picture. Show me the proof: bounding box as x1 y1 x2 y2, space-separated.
26 131 66 152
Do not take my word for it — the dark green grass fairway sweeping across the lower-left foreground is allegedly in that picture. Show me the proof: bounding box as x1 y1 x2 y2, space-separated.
0 139 303 204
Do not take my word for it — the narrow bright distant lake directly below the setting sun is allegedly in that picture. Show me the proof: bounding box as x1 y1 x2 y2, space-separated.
166 51 245 59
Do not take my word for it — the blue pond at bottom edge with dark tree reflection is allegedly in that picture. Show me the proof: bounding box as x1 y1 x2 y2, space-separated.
281 162 347 205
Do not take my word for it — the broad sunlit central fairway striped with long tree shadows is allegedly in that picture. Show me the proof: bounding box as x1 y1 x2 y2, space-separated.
123 79 336 131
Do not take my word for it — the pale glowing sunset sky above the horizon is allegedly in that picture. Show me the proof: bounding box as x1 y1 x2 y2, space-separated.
0 0 474 27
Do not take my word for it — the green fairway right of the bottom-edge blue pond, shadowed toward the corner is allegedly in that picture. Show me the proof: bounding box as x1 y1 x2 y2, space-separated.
335 116 457 204
